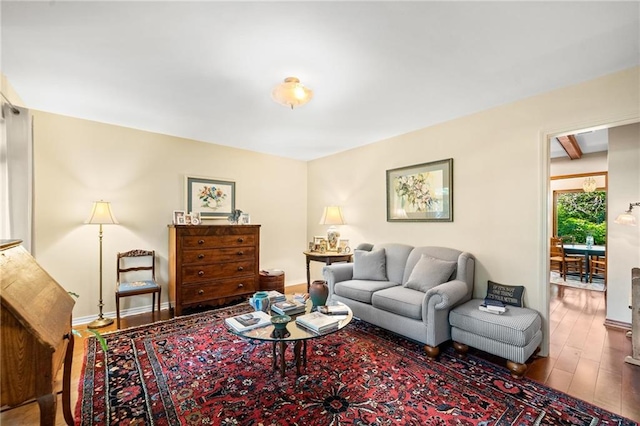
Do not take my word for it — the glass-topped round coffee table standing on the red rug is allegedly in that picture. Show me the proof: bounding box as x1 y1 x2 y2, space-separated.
225 300 353 377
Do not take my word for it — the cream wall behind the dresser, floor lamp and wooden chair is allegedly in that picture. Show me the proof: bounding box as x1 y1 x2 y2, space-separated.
34 111 307 323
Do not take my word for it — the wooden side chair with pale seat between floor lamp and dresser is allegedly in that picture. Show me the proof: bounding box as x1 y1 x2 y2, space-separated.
116 250 162 328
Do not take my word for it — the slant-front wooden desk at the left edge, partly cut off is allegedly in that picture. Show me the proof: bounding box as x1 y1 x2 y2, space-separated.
0 240 75 426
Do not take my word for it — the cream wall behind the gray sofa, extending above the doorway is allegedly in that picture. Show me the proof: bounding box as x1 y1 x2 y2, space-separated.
307 68 640 352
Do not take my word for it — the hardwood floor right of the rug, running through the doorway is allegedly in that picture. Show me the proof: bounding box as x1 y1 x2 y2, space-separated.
527 286 640 422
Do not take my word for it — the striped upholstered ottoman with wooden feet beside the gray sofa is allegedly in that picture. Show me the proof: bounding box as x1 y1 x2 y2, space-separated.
449 299 542 378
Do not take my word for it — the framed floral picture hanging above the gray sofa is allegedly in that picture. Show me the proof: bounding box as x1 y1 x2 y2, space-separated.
387 158 453 222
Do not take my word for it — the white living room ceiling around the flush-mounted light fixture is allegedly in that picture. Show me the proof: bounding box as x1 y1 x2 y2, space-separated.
0 0 640 160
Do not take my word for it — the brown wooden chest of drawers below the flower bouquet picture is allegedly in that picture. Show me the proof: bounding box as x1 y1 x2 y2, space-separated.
169 225 260 315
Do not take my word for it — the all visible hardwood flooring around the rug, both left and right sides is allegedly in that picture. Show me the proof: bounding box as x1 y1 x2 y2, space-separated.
0 284 640 426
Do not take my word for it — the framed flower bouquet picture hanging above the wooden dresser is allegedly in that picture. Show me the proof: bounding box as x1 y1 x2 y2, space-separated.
186 176 236 219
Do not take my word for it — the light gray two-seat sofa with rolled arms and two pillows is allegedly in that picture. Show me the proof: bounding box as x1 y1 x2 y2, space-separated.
322 244 475 358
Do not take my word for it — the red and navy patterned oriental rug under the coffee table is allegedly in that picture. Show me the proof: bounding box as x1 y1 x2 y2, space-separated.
76 304 636 426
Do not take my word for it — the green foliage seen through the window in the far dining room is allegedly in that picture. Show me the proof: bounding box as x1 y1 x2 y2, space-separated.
556 191 607 245
